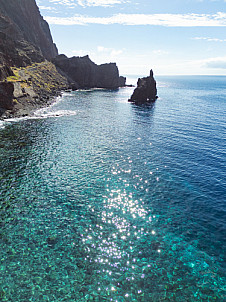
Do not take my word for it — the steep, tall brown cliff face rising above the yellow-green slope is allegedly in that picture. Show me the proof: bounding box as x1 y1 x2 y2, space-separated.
0 0 58 72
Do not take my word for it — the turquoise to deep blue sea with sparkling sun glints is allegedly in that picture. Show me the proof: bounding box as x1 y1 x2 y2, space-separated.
0 76 226 302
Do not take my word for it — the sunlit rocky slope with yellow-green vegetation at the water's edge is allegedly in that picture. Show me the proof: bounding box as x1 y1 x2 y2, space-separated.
0 61 68 118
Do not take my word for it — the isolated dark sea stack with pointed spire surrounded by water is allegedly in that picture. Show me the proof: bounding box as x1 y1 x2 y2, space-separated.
129 70 157 105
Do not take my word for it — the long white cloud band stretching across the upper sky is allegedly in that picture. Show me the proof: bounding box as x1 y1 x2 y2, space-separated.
45 12 226 27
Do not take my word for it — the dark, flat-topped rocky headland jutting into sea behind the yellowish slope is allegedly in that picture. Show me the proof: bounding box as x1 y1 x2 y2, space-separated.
52 55 126 89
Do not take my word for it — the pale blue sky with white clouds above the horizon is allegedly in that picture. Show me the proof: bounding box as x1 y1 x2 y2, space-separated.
36 0 226 76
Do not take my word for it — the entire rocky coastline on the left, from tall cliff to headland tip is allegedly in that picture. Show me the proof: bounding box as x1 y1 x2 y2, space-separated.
0 0 126 117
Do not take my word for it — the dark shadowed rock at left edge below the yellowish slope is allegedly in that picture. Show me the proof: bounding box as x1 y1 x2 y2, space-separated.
0 82 14 110
